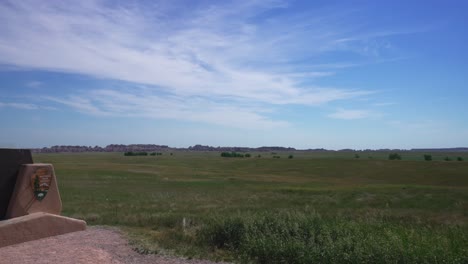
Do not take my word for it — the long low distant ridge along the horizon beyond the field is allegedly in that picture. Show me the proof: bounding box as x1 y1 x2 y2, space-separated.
31 144 468 153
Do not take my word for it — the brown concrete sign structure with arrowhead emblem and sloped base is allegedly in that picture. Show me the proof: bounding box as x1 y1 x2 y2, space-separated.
0 150 86 247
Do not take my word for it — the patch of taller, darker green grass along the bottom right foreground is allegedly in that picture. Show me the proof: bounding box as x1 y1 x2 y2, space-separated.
198 211 468 264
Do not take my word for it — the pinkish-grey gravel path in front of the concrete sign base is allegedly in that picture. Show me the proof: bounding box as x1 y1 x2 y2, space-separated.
0 227 227 264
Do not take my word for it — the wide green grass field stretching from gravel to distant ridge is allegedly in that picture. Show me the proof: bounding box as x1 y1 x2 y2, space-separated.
34 152 468 263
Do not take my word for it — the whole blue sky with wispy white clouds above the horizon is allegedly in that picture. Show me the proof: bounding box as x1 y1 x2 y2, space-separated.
0 0 468 149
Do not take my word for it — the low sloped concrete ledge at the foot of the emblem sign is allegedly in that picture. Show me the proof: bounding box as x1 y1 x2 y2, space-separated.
0 213 86 247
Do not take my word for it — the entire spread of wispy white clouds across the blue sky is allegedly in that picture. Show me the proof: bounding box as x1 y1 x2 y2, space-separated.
0 0 402 126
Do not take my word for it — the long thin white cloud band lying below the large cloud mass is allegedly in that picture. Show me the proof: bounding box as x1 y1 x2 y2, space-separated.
43 90 289 129
